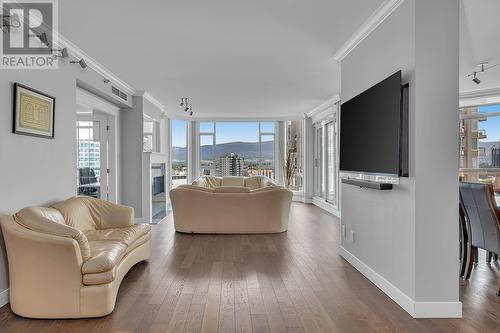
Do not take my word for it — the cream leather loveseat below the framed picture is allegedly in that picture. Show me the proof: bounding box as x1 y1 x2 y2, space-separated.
0 197 151 318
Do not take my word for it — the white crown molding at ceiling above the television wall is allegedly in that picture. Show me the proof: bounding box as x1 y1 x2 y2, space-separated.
333 0 404 62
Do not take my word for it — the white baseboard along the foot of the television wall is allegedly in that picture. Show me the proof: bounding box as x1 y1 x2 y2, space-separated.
340 246 462 318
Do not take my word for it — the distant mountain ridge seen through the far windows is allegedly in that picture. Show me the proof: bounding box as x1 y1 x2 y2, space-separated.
172 141 274 161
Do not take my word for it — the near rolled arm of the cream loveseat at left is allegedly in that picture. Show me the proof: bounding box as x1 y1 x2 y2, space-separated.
0 215 83 318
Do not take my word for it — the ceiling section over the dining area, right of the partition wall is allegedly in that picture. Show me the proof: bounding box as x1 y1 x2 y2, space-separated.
460 0 500 92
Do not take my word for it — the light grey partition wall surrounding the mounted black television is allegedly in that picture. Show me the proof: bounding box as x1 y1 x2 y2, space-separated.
340 0 461 317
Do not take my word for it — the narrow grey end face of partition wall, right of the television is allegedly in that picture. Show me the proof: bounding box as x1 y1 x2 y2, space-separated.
414 0 460 316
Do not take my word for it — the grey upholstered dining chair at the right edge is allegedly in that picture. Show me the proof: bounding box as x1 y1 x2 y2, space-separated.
460 182 500 296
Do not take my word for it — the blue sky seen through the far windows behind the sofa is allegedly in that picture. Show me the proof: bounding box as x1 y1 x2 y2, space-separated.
172 119 274 147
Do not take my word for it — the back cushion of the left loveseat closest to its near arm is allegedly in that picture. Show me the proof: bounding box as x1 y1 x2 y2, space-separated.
52 197 98 230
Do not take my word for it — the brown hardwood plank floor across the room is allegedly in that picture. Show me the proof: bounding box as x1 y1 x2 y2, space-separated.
0 203 500 333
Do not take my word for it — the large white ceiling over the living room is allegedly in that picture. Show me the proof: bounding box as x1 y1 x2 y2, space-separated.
59 0 383 118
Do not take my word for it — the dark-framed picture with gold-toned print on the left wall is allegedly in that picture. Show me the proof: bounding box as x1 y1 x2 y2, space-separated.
12 83 56 139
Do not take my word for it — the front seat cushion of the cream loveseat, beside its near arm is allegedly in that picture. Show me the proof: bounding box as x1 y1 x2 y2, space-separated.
82 240 127 274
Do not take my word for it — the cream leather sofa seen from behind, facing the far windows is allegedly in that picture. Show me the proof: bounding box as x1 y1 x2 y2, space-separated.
170 176 292 234
